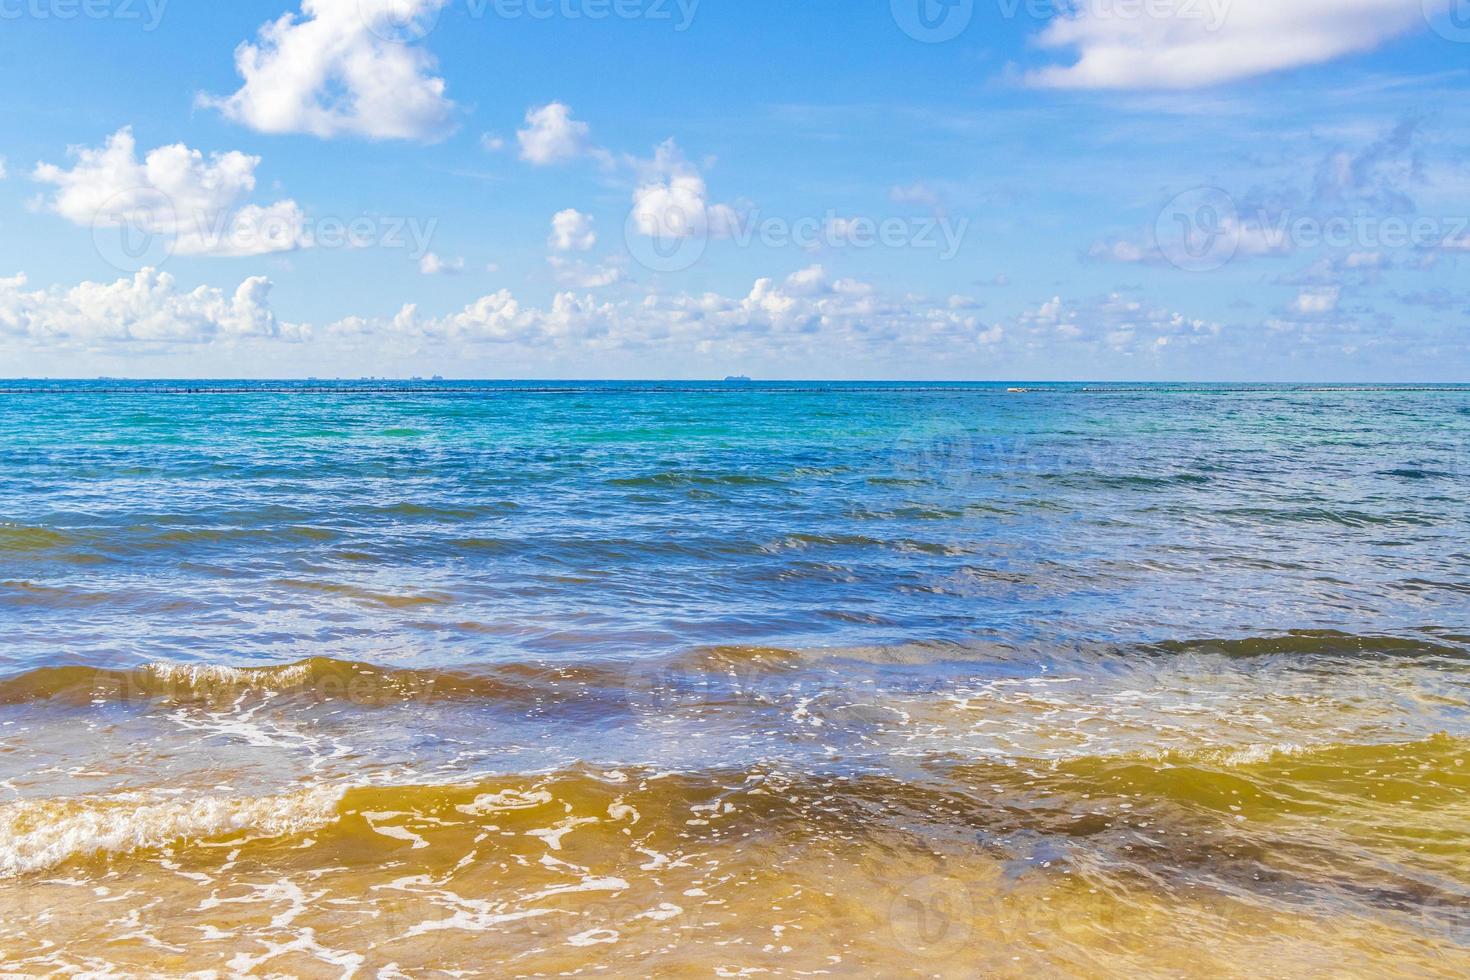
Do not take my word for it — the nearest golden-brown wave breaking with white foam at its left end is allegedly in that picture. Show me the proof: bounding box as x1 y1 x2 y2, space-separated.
0 736 1470 890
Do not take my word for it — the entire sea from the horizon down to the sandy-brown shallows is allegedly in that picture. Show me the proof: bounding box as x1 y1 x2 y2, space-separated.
0 382 1470 977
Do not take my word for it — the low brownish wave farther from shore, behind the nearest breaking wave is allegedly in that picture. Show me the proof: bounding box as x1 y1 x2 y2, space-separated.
0 628 1470 710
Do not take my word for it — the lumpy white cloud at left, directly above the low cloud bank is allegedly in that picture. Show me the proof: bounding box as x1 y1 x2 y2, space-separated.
32 128 309 256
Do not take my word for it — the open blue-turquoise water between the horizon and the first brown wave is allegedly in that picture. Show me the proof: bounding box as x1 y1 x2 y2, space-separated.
0 382 1470 671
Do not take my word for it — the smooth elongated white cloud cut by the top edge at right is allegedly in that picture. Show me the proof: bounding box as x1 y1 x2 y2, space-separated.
1028 0 1428 88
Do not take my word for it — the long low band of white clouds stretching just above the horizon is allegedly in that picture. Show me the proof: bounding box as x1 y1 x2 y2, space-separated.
0 264 1246 367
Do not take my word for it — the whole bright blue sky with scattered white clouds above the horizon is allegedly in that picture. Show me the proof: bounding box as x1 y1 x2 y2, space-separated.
0 0 1470 382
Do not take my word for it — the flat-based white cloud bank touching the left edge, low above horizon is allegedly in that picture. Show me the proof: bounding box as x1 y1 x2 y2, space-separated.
0 269 304 345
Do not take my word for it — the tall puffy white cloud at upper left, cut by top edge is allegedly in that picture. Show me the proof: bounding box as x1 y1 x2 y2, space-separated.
198 0 454 140
